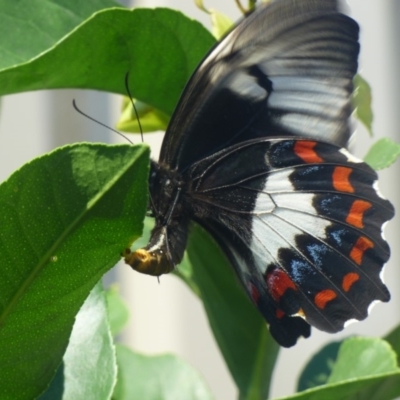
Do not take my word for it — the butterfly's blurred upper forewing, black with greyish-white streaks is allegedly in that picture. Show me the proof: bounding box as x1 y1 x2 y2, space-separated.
160 0 359 171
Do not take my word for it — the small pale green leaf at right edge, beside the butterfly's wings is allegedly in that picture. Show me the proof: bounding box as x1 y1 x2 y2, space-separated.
364 138 400 170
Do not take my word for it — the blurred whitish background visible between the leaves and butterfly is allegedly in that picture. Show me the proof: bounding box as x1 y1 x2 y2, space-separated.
0 0 400 400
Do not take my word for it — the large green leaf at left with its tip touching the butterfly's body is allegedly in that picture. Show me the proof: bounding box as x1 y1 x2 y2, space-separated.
0 144 149 400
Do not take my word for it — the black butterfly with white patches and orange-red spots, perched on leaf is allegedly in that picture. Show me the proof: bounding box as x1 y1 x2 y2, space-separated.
125 0 394 347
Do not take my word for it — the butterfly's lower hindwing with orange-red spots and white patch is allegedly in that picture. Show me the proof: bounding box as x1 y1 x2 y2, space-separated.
187 138 394 347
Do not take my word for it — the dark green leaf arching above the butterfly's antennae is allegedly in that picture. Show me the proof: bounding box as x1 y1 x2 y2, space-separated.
0 8 215 115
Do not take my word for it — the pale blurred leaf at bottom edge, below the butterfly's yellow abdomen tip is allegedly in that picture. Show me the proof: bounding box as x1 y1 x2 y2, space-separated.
113 345 213 400
